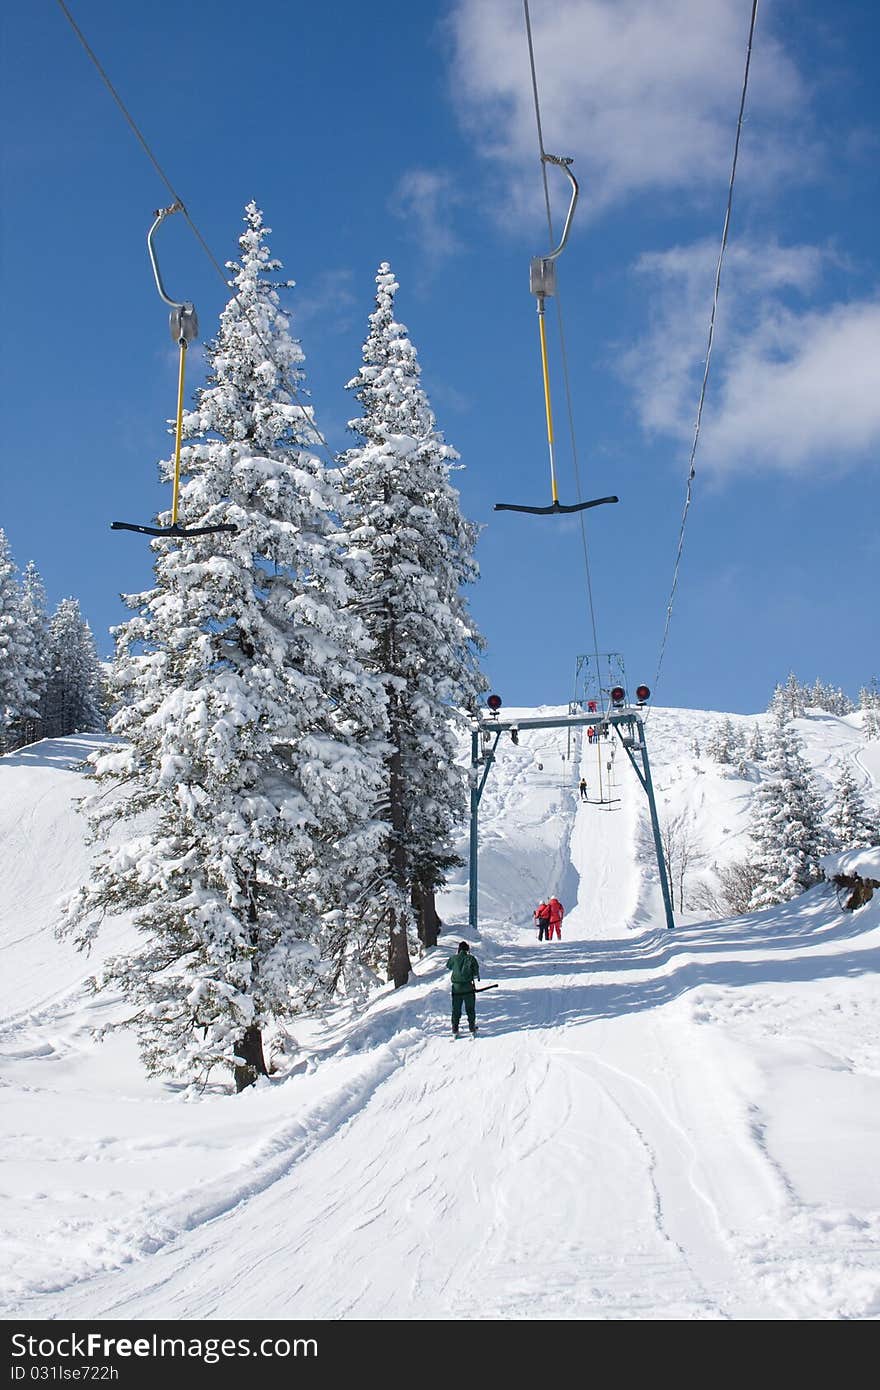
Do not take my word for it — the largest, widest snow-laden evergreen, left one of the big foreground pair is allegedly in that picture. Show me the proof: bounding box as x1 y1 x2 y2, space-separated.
65 203 386 1088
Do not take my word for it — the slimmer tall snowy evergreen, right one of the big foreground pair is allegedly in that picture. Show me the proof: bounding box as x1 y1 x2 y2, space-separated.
342 263 485 984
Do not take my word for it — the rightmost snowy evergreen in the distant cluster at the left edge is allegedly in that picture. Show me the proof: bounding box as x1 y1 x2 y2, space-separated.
40 599 104 738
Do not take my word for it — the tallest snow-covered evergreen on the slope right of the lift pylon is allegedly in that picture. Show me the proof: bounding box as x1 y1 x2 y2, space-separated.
749 710 829 908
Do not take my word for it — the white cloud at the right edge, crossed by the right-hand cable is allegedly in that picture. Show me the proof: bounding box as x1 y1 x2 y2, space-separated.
621 242 880 474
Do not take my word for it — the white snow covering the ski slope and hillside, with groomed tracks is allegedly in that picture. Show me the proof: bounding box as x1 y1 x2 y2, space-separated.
0 709 880 1321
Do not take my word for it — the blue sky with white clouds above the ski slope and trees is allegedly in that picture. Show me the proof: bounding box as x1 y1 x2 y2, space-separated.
0 0 880 713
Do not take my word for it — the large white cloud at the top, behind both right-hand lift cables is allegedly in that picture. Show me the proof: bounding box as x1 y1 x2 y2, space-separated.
452 0 804 214
